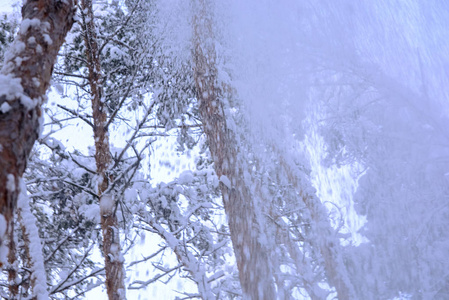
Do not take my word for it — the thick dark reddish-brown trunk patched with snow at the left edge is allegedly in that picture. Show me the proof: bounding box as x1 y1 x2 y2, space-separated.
0 0 75 264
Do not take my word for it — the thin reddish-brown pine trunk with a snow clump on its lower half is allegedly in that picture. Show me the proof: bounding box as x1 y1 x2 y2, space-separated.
81 0 126 300
